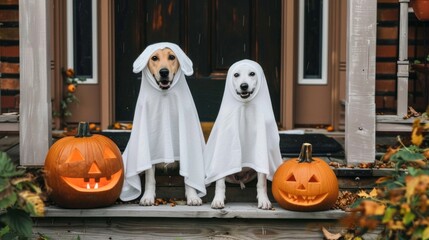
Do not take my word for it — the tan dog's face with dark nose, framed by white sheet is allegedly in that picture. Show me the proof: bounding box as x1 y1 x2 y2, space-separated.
147 48 180 90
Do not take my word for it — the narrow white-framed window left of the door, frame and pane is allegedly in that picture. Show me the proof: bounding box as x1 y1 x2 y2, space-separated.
67 0 98 84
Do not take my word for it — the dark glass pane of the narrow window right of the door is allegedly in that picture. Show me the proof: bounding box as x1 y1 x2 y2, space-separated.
302 0 323 78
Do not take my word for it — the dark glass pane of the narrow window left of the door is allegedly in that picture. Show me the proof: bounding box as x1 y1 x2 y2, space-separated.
73 0 92 78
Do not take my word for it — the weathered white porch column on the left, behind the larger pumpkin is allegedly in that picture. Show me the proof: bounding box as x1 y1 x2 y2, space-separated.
19 0 52 166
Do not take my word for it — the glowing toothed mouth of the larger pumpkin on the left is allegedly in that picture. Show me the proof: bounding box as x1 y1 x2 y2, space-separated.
61 169 122 192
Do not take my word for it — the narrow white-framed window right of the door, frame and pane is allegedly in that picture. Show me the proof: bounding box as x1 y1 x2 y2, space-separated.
298 0 328 85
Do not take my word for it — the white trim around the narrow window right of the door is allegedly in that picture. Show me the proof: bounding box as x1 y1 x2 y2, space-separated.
298 0 329 85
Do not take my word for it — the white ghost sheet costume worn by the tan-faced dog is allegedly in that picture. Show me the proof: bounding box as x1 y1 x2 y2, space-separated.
120 42 206 201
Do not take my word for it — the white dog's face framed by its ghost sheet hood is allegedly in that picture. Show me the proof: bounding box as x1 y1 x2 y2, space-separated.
232 65 258 100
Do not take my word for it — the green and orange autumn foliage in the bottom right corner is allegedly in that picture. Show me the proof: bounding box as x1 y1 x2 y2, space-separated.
345 118 429 239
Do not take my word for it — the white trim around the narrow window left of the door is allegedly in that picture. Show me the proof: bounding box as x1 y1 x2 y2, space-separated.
67 0 98 84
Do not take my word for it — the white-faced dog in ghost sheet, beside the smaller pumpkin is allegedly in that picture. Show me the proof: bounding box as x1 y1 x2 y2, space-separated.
204 60 282 209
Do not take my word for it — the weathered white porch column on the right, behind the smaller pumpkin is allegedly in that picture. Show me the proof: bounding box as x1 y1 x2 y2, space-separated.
345 0 377 164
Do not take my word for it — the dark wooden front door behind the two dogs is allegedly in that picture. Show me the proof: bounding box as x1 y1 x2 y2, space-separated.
115 0 281 121
